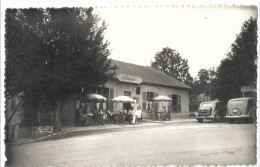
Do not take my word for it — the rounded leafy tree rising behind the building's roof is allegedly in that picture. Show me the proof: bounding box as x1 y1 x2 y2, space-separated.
151 47 192 85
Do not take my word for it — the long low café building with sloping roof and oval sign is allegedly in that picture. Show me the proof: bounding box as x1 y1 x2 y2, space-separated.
88 60 191 119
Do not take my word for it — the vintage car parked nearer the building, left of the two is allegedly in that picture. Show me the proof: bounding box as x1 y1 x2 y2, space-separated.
195 101 226 123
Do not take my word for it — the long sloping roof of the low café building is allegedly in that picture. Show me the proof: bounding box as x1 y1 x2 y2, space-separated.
112 60 191 89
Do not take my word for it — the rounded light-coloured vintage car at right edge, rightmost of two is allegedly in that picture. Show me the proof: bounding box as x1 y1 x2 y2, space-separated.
225 97 256 123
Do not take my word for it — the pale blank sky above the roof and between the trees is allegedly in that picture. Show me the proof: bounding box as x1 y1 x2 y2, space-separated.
95 7 257 77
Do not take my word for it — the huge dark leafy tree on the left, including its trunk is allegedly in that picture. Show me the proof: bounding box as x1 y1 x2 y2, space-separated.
5 8 115 131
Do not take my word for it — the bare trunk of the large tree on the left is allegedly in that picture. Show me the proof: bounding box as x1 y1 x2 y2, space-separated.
53 100 61 132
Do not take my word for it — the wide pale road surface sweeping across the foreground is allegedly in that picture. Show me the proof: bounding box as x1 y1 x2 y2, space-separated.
5 121 256 166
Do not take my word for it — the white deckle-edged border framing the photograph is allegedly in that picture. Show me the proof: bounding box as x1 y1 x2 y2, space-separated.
0 0 260 166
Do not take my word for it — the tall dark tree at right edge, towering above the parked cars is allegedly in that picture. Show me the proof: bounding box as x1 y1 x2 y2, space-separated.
214 18 257 100
